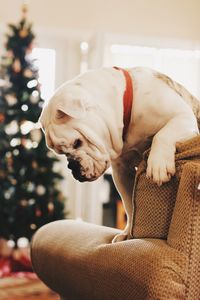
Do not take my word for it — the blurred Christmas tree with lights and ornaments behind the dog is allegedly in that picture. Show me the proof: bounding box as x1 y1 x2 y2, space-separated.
0 7 64 241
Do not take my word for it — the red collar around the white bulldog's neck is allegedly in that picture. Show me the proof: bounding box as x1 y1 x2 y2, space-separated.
114 67 133 141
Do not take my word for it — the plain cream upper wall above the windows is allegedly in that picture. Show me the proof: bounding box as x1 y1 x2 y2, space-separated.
0 0 200 39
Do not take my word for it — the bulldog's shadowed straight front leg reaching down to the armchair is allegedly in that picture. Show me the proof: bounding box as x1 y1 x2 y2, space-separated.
112 161 138 243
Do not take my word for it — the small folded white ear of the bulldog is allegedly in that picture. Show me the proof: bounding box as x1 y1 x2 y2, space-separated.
56 99 87 119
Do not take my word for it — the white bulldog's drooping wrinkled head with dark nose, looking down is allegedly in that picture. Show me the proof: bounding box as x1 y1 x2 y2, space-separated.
40 82 110 182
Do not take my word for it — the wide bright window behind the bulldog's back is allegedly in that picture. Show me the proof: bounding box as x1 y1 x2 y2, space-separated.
104 44 200 98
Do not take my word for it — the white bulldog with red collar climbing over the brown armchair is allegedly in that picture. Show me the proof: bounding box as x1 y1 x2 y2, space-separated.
40 68 200 242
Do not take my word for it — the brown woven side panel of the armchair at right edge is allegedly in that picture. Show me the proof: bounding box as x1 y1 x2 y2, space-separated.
167 161 200 299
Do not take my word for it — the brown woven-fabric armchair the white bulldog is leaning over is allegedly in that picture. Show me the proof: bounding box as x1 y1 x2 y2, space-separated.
31 137 200 300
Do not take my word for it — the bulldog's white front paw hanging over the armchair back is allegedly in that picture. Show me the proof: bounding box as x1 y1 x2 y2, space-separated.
147 149 175 186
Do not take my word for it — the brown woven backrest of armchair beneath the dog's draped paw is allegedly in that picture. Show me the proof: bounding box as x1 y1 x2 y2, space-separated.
131 136 200 239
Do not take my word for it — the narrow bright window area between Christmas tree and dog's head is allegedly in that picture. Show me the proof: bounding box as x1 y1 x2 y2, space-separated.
32 48 56 100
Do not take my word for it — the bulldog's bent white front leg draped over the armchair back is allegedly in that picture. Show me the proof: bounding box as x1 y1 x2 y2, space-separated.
147 111 199 185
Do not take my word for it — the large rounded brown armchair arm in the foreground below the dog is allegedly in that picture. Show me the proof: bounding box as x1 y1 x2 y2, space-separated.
32 220 188 300
